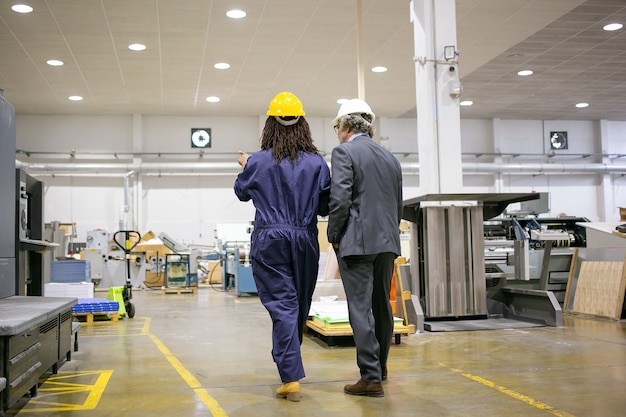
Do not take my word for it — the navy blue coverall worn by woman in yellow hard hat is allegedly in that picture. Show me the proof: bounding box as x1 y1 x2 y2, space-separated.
234 149 330 382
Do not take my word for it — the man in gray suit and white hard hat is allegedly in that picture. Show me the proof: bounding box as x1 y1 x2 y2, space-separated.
327 99 402 397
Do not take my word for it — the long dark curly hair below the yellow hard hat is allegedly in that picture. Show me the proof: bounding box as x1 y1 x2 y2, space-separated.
261 116 319 163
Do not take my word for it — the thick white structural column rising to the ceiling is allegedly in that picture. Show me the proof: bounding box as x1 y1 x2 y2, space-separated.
410 0 463 194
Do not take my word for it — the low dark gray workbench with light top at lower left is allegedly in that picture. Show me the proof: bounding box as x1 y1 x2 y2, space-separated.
0 296 77 415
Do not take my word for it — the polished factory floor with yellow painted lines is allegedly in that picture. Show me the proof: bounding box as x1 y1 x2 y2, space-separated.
7 286 626 417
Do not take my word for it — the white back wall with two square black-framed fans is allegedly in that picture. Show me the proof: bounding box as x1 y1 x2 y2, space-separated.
16 115 626 244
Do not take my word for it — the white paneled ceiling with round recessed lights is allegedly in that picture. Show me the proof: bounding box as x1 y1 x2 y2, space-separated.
0 0 626 120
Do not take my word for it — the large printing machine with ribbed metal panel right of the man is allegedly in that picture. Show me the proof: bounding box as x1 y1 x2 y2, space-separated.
401 193 587 331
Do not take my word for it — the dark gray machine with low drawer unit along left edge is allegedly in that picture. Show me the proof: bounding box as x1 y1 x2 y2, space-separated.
0 90 77 415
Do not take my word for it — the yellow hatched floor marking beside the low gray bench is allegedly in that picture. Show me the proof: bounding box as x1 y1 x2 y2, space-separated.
20 369 113 414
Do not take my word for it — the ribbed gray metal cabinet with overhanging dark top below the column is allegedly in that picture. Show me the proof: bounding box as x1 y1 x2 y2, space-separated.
403 194 539 318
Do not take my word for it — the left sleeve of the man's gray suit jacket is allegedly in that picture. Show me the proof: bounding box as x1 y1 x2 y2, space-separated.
327 145 354 243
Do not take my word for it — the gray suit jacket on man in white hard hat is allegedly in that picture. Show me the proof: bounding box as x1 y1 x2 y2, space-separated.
327 134 402 257
